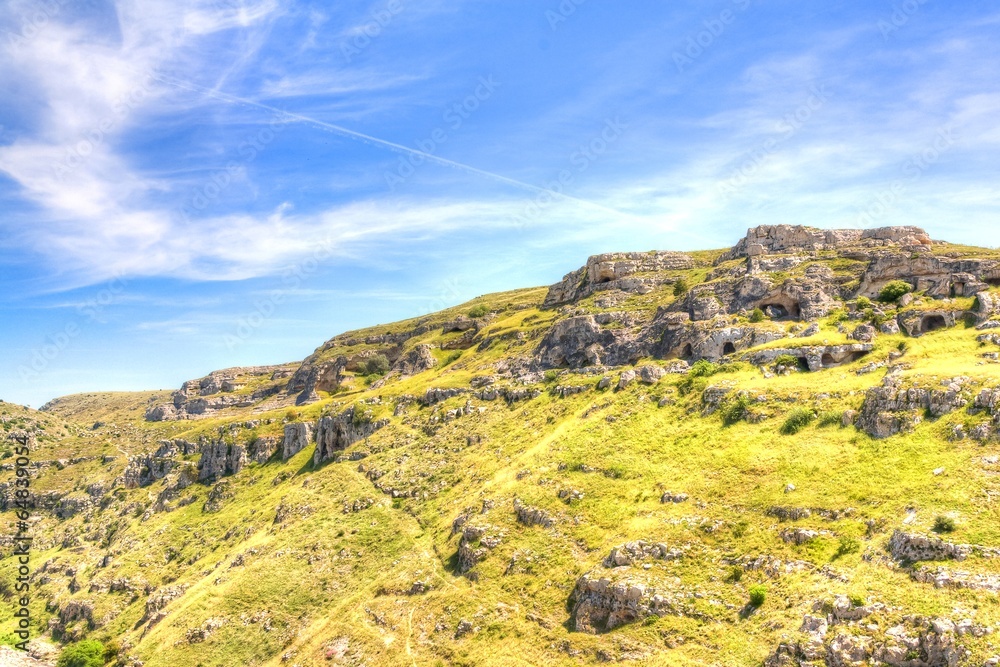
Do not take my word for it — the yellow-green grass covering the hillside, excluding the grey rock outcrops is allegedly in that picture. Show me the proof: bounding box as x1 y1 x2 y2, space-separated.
0 228 1000 667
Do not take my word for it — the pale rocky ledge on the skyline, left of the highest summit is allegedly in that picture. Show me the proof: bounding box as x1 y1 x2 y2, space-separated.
544 252 694 307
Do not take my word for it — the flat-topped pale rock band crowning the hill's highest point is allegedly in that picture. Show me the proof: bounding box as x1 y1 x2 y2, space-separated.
716 225 932 264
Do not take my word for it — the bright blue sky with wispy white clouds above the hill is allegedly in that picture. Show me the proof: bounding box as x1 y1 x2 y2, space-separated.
0 0 1000 406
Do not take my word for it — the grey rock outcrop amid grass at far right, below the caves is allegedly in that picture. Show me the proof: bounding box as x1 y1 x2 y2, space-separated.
856 373 969 438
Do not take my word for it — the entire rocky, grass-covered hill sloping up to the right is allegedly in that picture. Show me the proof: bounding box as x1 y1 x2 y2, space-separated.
0 225 1000 667
